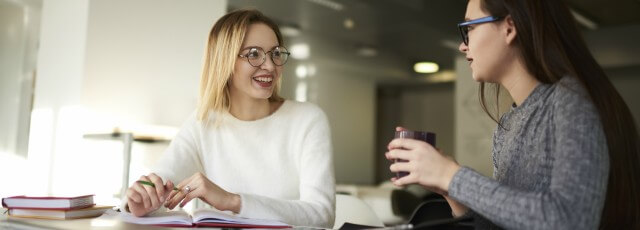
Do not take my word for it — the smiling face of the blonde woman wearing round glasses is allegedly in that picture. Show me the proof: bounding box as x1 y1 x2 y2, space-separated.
230 23 282 100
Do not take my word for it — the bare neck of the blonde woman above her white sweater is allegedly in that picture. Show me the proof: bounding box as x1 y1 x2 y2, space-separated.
229 91 271 121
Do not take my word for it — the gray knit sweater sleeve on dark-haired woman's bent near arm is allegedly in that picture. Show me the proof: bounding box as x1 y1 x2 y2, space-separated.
449 90 609 229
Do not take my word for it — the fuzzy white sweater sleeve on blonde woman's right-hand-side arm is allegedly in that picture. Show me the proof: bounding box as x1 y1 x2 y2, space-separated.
239 108 335 228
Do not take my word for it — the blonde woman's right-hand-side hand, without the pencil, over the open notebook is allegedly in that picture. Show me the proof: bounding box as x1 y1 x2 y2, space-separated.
165 173 241 213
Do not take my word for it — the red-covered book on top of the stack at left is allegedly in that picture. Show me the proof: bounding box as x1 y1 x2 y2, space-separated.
2 195 95 210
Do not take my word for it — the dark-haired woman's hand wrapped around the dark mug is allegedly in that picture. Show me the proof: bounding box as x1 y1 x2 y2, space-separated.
385 138 460 195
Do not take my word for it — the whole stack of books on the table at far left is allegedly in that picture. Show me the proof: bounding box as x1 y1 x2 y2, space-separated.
2 195 113 220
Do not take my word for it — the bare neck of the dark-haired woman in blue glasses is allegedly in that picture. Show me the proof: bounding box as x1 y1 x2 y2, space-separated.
500 58 540 106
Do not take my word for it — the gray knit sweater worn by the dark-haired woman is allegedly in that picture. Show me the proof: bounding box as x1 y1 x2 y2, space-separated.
449 77 609 229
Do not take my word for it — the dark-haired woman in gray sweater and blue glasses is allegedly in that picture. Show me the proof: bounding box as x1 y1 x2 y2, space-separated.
386 0 640 229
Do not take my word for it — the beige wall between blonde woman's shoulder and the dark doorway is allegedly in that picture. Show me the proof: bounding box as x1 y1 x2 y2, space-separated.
282 60 382 184
